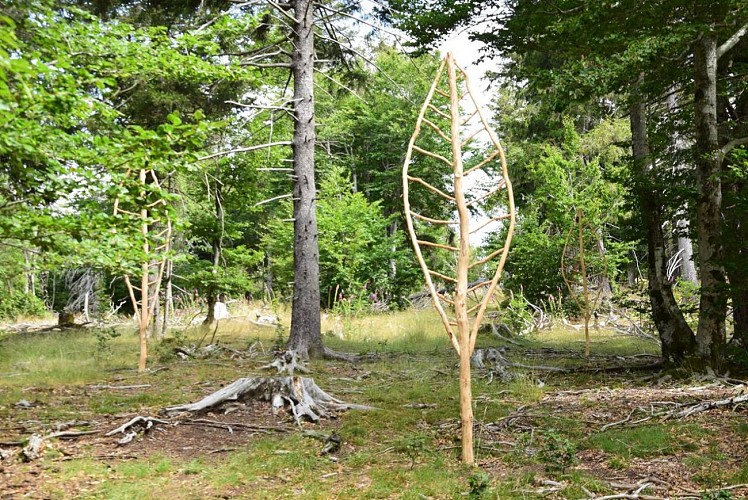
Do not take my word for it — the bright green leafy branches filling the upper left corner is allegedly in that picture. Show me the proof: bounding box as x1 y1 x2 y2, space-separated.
0 2 254 308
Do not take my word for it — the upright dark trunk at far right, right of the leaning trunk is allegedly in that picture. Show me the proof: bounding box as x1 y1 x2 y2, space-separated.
694 33 727 368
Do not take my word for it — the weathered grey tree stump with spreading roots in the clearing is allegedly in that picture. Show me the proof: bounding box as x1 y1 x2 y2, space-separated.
166 376 373 422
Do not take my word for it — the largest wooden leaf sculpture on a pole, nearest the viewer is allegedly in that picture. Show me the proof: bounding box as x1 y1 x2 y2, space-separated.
403 53 515 464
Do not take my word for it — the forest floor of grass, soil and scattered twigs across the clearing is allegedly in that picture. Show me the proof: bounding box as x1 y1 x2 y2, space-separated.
0 312 748 499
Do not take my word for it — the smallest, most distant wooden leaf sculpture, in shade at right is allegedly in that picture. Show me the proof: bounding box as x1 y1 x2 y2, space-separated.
561 208 608 358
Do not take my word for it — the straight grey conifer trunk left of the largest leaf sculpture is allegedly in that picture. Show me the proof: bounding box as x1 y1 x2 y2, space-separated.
287 0 324 358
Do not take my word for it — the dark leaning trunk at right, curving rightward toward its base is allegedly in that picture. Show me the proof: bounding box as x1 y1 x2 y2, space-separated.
630 101 696 363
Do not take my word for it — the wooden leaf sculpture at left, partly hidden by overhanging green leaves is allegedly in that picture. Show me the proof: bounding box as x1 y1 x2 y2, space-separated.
114 169 171 372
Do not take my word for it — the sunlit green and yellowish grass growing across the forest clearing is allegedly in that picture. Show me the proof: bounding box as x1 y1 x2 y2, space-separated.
0 310 748 499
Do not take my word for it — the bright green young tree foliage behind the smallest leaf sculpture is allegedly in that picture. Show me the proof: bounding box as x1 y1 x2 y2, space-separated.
491 119 628 304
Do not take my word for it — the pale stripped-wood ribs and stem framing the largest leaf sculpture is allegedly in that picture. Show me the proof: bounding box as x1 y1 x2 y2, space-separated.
403 53 515 464
